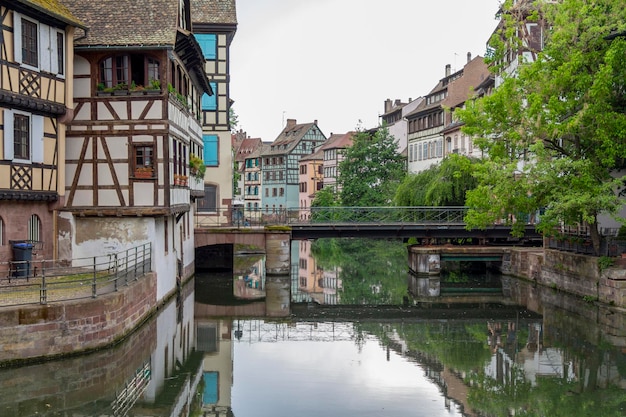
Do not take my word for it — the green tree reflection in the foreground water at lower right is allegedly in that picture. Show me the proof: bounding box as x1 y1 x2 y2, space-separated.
358 321 626 417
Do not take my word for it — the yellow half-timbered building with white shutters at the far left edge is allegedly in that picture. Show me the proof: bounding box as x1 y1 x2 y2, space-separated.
0 0 84 262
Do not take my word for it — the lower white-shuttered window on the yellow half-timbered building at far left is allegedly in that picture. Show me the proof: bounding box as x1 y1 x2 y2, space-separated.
4 109 44 163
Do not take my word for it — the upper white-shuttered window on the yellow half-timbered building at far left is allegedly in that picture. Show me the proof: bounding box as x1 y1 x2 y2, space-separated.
13 13 66 76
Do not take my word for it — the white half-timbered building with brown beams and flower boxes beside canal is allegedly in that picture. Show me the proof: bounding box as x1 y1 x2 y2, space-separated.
59 0 212 299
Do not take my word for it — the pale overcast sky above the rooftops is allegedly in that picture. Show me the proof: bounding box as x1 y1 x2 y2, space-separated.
230 0 500 142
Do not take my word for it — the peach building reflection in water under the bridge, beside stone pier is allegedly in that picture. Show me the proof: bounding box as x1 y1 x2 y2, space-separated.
297 240 341 305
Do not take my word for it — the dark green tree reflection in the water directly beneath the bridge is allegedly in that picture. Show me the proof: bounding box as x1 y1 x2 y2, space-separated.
311 239 408 305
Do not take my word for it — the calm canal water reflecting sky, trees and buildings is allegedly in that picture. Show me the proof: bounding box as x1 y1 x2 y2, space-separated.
0 240 626 417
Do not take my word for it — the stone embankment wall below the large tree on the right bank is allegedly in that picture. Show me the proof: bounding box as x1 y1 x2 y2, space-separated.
507 249 626 307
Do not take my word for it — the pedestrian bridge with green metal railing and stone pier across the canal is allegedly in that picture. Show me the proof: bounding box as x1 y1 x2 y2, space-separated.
194 207 542 275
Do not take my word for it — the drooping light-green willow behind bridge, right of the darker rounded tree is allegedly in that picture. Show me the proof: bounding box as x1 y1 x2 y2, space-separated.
394 154 479 206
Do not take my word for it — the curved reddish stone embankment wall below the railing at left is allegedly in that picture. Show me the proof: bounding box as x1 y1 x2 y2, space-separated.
0 273 157 366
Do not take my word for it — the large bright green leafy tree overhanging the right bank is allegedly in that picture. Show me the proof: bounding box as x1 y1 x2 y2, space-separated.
457 0 626 253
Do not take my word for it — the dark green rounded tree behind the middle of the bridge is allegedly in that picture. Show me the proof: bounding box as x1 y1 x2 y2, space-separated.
337 126 406 207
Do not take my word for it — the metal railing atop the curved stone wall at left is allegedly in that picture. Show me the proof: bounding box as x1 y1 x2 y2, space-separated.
0 243 152 306
